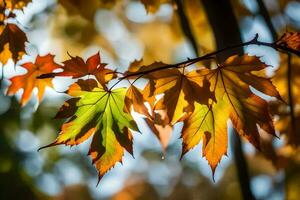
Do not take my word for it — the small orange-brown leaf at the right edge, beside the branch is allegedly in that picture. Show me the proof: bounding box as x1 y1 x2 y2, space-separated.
276 32 300 51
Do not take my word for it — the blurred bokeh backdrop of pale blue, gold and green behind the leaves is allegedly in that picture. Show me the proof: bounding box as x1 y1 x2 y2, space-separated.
0 0 300 200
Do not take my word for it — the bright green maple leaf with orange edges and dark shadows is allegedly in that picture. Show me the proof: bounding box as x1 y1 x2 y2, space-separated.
42 79 138 180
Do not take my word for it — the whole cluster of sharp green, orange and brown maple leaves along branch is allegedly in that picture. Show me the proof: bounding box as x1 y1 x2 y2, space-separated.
0 0 300 184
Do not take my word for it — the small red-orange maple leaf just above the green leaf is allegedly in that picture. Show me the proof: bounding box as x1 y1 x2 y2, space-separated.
39 52 116 87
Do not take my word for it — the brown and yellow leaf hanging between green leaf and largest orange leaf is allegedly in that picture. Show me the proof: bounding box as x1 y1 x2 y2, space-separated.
152 69 214 124
